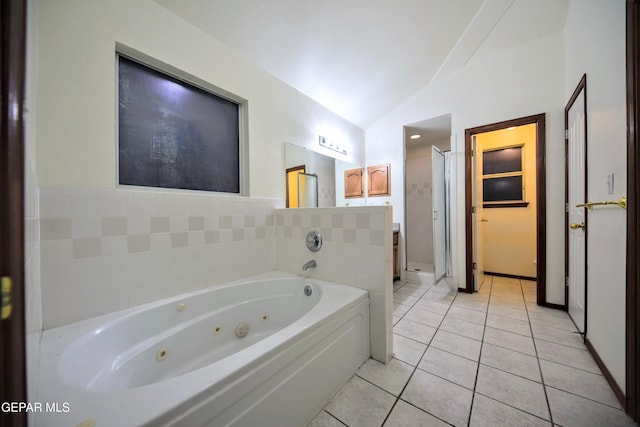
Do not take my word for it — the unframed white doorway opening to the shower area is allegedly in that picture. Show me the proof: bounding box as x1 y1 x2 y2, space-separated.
403 115 451 284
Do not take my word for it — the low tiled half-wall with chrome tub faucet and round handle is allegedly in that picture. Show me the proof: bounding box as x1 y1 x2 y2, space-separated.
275 206 393 363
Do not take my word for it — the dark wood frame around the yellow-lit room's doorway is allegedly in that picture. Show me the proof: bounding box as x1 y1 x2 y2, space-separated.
459 113 558 308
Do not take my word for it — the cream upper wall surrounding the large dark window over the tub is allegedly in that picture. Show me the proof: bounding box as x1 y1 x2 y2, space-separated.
34 0 364 198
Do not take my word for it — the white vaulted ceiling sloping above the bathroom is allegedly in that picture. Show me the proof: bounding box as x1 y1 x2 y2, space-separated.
155 0 569 129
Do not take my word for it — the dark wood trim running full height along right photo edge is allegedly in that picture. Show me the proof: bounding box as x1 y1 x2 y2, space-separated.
625 0 640 421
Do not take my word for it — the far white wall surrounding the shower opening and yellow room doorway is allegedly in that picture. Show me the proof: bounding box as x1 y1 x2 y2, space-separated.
366 33 565 304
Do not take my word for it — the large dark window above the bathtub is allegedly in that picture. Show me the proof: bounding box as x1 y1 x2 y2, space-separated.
118 55 241 194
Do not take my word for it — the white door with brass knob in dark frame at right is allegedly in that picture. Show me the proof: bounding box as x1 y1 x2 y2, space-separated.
567 86 587 333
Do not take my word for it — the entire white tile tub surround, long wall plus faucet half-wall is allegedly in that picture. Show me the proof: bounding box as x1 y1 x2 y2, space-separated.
39 187 393 362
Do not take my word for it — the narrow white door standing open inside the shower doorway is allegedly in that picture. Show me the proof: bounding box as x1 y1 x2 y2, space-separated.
431 146 447 283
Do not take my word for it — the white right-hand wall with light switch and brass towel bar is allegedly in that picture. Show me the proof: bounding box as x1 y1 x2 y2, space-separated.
565 0 627 391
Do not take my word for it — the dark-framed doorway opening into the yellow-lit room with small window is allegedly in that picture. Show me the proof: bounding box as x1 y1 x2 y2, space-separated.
460 114 547 305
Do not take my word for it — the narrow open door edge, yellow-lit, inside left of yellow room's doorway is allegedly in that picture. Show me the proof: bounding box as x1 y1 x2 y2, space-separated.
471 135 484 291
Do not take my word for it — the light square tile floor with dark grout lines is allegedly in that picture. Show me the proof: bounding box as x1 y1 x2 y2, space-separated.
309 276 635 427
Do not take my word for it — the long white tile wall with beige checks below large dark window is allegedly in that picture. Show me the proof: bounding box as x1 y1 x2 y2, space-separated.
39 187 282 329
